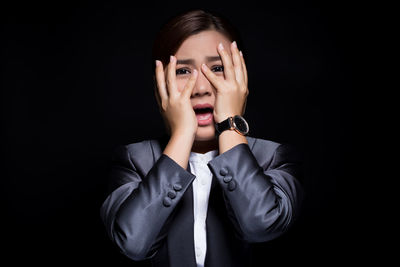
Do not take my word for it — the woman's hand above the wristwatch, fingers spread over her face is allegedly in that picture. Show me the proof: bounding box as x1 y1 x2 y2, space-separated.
202 42 249 123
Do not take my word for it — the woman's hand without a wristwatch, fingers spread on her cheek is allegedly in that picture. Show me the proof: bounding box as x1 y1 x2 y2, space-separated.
156 56 198 136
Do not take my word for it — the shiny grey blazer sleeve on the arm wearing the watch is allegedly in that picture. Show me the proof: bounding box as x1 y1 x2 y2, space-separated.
208 144 302 242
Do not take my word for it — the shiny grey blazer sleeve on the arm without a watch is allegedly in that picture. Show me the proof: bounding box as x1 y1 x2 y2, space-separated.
100 146 195 261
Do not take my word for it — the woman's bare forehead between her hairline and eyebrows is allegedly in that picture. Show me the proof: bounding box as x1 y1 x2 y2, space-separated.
175 30 230 58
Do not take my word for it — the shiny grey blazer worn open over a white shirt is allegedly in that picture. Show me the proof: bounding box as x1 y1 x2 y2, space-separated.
101 136 302 267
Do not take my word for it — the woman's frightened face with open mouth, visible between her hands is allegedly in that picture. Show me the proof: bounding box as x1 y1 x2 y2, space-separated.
175 30 231 141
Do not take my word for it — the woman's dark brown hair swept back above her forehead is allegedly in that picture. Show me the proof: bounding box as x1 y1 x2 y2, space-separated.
153 9 242 66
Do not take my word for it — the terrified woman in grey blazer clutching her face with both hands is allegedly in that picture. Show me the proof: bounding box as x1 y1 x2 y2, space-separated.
101 10 301 267
